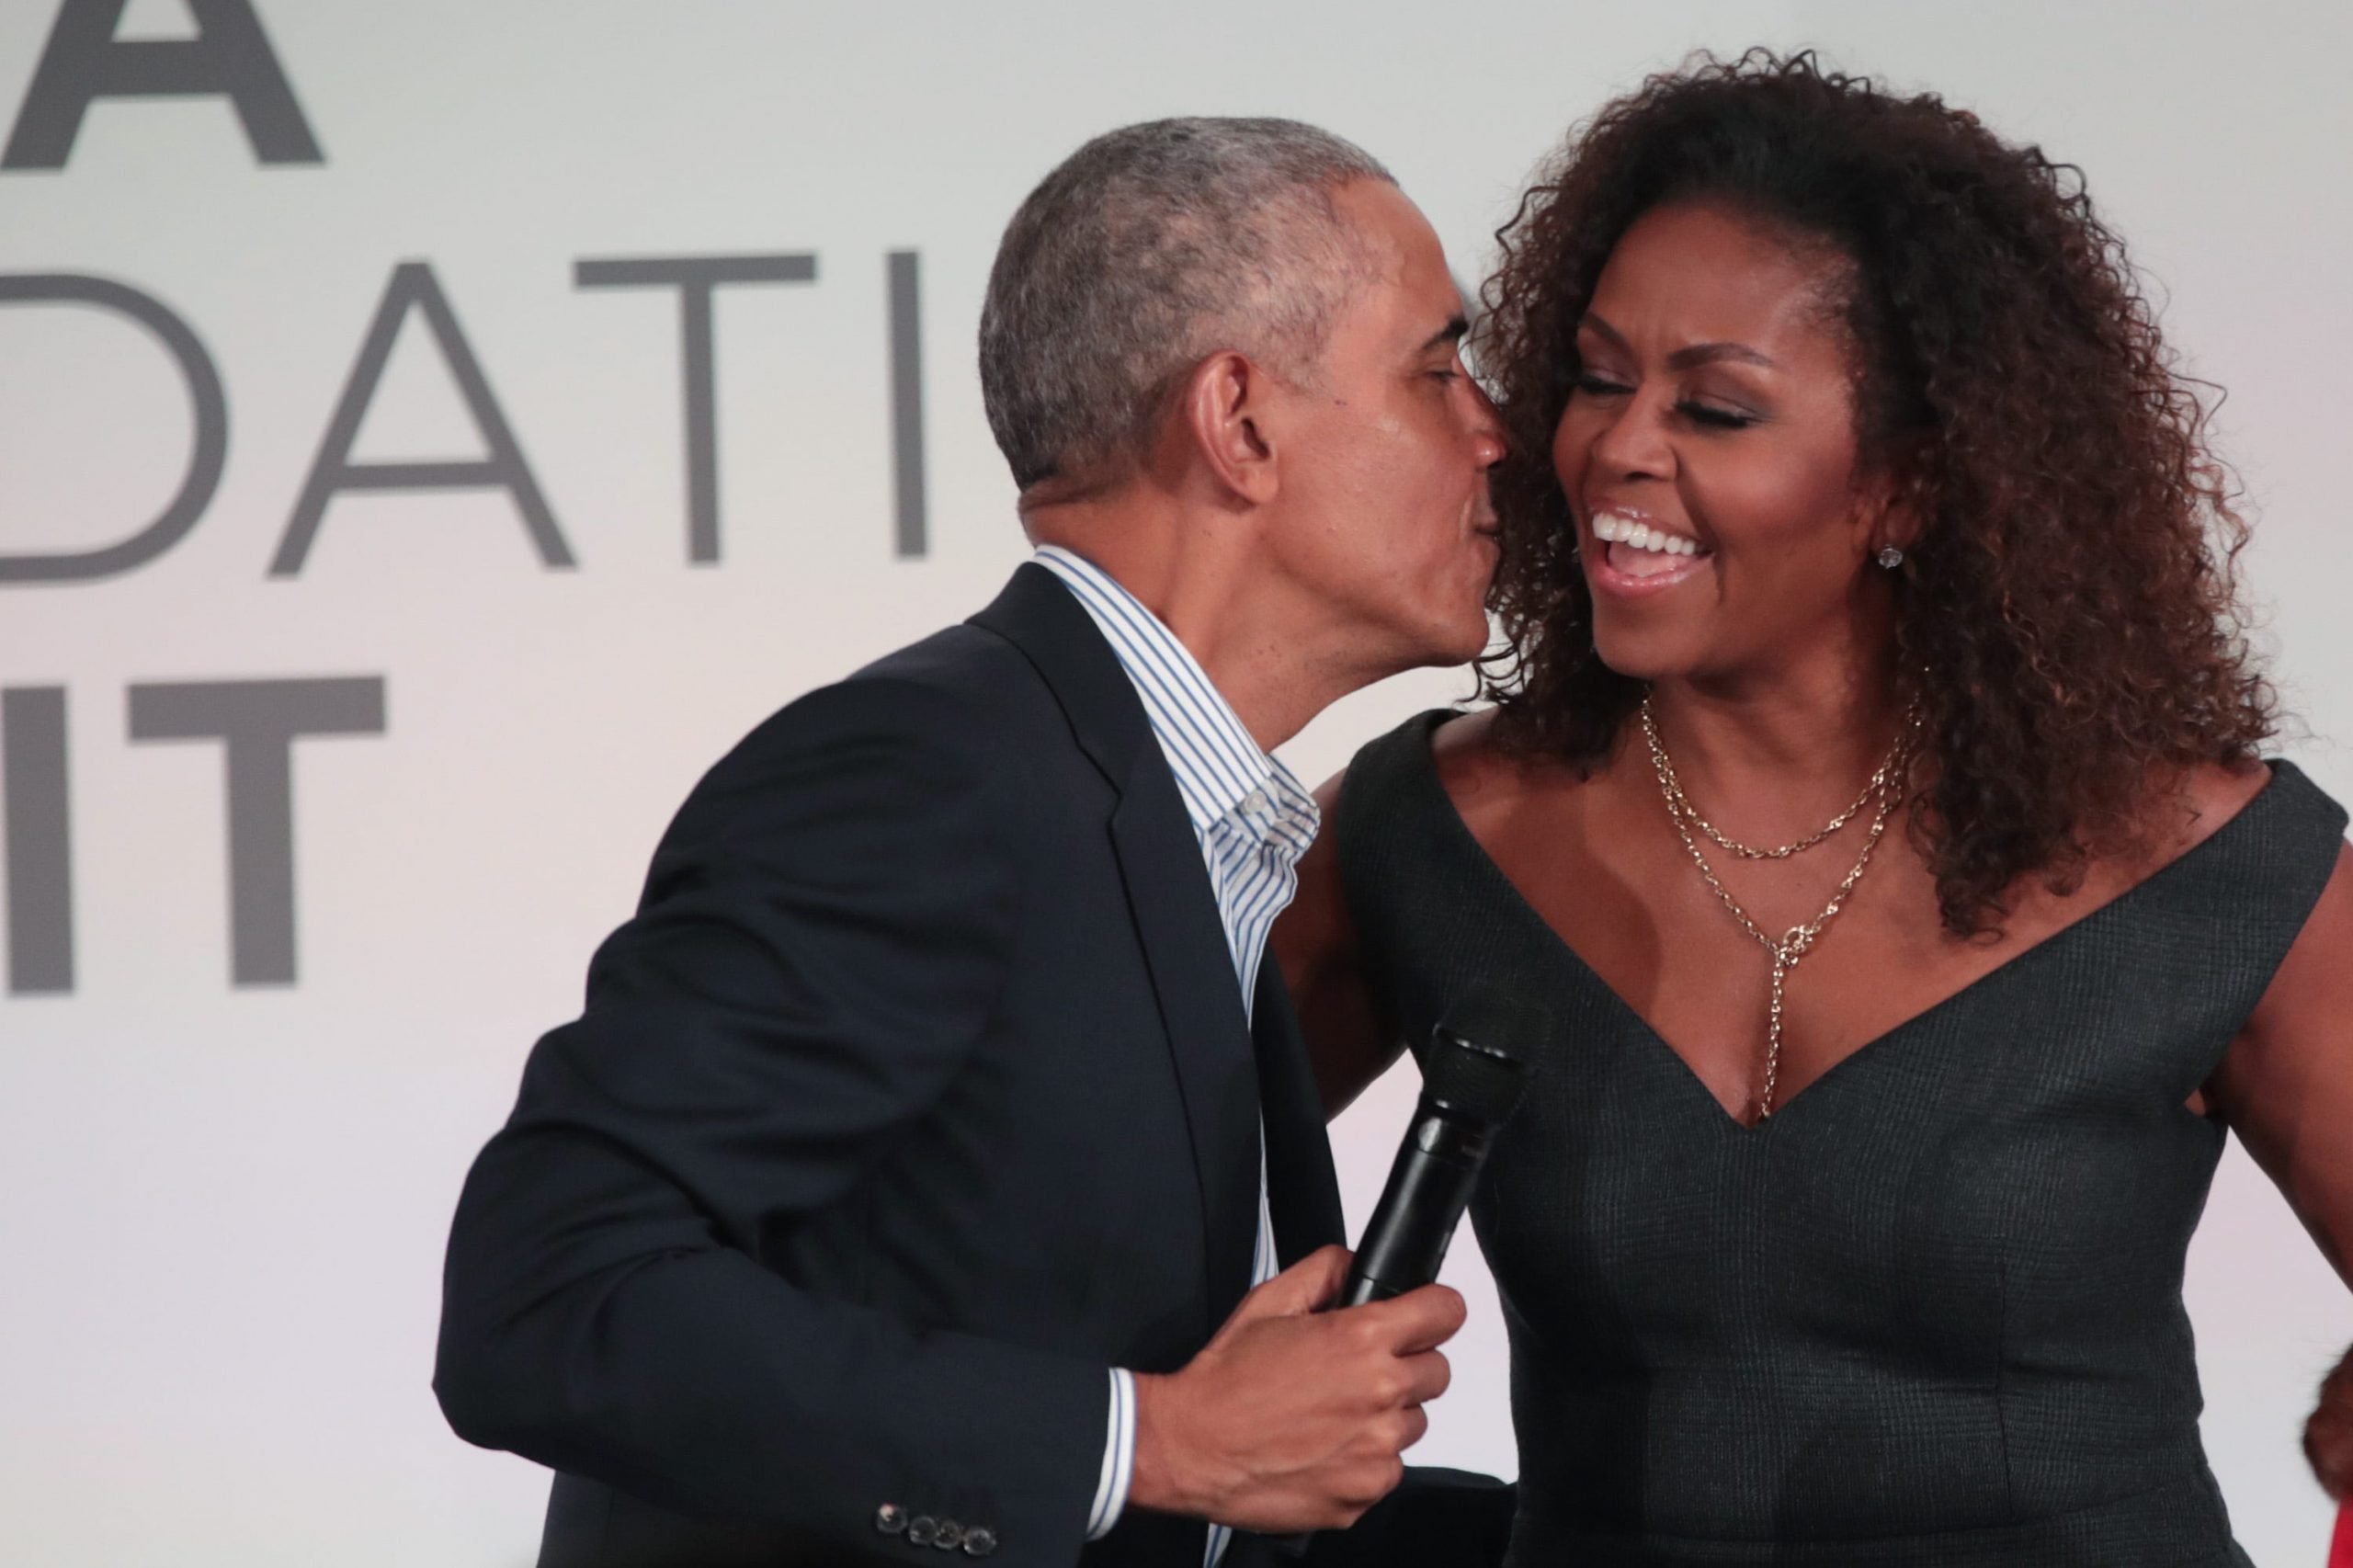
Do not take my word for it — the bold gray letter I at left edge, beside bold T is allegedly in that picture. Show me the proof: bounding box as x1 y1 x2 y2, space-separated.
0 685 73 996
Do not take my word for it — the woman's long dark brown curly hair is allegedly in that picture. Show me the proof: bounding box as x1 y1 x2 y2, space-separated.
1475 50 2276 935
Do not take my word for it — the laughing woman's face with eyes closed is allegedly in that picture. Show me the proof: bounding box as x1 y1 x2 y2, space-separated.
1553 205 1901 680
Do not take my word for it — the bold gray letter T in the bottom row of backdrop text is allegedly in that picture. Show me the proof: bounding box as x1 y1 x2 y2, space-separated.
131 676 383 986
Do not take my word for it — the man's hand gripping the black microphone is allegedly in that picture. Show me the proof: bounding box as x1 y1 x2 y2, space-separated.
1127 1248 1463 1533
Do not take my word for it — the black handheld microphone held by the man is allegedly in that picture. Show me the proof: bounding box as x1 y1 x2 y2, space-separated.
1332 996 1541 1307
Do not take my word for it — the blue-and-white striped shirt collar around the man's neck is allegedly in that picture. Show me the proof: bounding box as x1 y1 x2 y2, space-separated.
1030 544 1318 855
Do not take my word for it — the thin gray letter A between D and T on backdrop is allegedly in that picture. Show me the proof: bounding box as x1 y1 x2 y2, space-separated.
270 261 572 577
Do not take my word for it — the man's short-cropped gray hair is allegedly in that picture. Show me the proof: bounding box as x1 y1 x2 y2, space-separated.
982 118 1395 490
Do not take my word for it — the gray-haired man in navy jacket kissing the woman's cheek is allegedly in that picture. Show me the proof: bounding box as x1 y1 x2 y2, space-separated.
436 120 1501 1568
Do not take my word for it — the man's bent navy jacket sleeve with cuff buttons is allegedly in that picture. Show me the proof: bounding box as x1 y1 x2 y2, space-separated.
436 680 1108 1563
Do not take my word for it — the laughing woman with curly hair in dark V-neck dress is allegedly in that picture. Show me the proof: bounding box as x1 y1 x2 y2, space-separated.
1278 54 2353 1568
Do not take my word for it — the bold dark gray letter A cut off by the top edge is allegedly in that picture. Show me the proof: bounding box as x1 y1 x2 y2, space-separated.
0 0 324 169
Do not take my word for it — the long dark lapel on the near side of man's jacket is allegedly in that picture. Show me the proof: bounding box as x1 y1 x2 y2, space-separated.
972 565 1270 1335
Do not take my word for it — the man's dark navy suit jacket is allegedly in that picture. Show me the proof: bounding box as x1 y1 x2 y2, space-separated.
436 565 1341 1568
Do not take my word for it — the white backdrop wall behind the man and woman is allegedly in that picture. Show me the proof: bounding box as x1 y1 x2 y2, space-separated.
0 0 2353 1568
